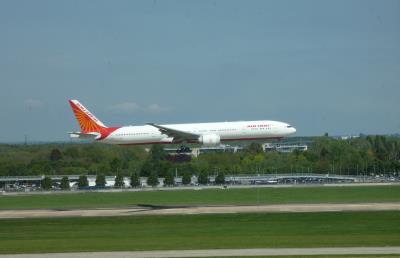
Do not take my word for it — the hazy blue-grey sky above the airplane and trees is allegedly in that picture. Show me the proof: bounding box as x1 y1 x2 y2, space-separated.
0 0 400 142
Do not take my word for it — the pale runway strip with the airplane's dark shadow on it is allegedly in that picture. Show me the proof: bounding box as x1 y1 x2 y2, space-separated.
0 202 400 219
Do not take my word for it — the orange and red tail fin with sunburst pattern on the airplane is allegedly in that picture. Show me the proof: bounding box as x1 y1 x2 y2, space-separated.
69 100 107 134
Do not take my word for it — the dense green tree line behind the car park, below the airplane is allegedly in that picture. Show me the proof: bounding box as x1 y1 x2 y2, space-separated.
0 135 400 181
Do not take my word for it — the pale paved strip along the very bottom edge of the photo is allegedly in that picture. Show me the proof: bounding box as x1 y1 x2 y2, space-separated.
0 247 400 258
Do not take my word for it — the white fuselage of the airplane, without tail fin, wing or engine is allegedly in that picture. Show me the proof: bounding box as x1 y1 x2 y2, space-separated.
99 120 296 144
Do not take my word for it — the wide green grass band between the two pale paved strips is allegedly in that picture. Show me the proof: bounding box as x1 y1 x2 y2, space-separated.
0 212 400 253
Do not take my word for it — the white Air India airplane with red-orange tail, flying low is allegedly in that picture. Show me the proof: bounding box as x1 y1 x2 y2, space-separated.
69 100 296 146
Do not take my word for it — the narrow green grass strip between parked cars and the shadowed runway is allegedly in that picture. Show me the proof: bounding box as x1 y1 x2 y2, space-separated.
0 185 400 209
